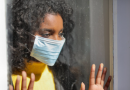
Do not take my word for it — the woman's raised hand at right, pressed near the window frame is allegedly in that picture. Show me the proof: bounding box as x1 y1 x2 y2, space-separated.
80 64 111 90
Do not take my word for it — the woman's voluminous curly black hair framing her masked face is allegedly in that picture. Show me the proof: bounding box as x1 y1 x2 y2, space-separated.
7 0 74 72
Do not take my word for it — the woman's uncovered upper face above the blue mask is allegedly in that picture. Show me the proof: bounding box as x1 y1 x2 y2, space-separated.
35 14 63 40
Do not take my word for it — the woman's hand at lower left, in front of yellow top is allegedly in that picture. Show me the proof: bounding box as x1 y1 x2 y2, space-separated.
9 71 35 90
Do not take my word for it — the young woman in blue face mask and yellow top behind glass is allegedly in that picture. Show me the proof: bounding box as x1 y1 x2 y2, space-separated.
8 0 111 90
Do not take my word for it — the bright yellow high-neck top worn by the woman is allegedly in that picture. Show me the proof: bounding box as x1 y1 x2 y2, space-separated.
12 62 55 90
